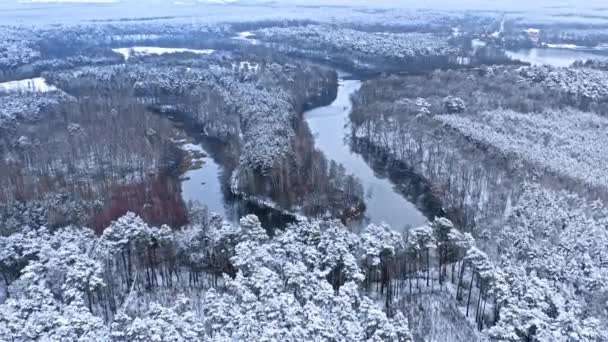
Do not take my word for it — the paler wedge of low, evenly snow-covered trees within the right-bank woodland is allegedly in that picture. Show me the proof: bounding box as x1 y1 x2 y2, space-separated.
435 107 608 187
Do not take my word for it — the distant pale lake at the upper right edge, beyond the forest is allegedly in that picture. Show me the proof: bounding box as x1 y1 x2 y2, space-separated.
506 48 608 67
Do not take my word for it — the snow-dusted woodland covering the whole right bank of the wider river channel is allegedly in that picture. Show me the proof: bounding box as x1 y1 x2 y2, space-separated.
351 67 607 340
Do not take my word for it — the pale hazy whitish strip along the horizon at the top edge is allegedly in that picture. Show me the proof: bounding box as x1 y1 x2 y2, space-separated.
0 0 608 24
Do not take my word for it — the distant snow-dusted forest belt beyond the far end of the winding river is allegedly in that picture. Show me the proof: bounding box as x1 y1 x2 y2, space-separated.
255 25 459 70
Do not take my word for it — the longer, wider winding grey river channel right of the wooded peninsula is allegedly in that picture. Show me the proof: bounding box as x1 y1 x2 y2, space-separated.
305 80 427 231
